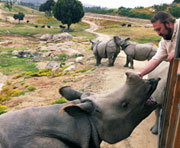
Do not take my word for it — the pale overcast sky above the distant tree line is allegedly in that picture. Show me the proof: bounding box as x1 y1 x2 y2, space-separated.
79 0 174 8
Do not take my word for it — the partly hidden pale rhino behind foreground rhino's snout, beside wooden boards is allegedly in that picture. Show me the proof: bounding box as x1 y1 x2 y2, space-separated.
148 62 169 134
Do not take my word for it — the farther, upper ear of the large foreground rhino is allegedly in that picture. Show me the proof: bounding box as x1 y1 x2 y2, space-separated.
59 86 83 101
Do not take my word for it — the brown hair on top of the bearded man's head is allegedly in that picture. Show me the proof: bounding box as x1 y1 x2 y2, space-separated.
151 11 176 24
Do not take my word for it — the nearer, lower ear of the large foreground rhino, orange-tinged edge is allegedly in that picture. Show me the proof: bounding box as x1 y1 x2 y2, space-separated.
61 101 94 116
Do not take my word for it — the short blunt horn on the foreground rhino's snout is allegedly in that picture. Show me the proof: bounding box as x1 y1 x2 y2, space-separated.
125 71 142 84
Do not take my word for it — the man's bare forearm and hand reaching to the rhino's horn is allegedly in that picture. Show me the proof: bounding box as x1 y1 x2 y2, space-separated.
138 59 162 78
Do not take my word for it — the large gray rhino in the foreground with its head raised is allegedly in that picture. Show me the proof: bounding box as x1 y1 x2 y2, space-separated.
0 72 159 148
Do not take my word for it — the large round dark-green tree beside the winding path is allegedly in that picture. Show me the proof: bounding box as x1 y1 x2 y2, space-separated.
53 0 84 30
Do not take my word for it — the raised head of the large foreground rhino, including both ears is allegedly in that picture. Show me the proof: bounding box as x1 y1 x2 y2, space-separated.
60 72 160 144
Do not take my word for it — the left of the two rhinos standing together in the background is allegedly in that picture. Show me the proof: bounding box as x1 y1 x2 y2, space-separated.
90 38 120 66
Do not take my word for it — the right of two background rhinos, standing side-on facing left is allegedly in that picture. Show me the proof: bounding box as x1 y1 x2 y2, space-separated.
114 36 158 69
